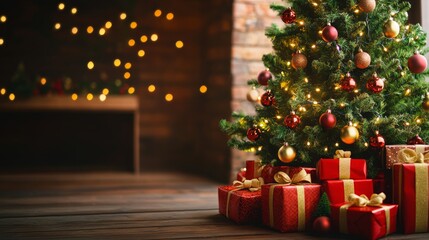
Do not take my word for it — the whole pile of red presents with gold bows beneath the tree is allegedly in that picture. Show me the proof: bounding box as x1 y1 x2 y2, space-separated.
218 145 429 239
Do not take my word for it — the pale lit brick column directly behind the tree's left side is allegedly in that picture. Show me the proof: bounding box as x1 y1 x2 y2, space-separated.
231 0 281 178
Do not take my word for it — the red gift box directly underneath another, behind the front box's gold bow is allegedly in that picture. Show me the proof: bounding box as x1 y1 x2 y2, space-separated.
324 179 374 204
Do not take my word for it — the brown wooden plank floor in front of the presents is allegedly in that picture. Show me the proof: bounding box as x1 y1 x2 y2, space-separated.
0 173 429 239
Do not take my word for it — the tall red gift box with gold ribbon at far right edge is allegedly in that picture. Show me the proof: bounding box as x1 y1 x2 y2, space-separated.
392 163 429 233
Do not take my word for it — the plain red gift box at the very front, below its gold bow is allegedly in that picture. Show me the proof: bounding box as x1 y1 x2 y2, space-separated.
331 203 398 239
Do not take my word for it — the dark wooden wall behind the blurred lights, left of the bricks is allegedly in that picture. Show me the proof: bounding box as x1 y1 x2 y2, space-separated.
0 0 232 179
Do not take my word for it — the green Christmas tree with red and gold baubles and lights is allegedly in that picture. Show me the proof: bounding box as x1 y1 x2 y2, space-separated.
220 0 429 174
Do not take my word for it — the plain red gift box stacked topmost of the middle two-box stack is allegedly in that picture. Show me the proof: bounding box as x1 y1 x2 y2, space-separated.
317 158 366 181
